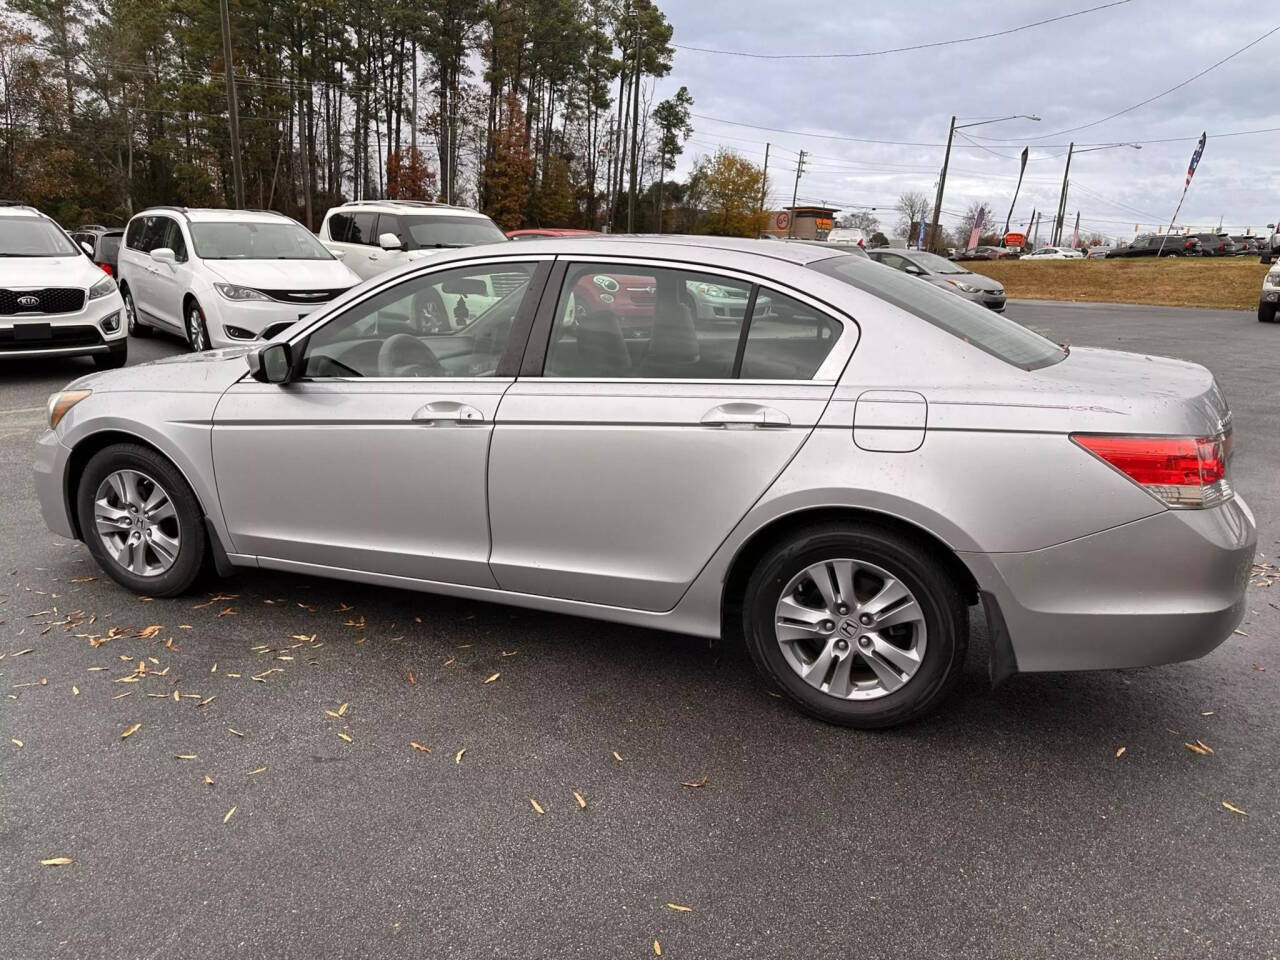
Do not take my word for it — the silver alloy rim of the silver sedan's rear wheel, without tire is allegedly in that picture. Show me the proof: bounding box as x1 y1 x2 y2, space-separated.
774 559 927 700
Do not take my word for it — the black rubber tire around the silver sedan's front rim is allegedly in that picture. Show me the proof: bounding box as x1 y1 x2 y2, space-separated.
76 443 209 596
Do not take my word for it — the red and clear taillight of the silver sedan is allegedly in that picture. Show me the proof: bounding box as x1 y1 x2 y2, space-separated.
1071 428 1231 507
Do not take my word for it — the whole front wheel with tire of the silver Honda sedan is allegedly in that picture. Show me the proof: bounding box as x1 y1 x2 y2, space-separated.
76 443 207 596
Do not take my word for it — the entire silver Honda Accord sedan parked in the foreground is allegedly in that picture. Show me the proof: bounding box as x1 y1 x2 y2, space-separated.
36 237 1256 727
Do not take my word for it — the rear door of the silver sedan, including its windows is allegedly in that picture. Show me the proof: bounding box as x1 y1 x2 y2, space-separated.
489 259 856 611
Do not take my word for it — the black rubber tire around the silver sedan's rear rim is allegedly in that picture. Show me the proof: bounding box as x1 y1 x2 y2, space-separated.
742 524 969 730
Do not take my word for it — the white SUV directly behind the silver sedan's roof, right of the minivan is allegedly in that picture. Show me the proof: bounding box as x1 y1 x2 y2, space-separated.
320 200 507 280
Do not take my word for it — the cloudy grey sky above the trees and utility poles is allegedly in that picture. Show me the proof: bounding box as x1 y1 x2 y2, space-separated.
658 0 1280 242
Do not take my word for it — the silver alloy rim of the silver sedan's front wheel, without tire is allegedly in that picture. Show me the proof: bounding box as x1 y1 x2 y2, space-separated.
93 470 182 577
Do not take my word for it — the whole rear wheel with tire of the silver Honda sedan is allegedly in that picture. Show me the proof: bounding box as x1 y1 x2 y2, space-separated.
742 525 969 727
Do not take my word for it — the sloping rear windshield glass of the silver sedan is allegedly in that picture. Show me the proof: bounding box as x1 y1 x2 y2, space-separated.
809 256 1066 370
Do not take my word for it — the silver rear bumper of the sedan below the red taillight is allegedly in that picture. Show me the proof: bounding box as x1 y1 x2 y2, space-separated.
961 497 1257 672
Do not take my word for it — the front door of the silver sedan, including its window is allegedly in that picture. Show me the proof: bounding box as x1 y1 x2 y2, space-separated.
212 256 550 588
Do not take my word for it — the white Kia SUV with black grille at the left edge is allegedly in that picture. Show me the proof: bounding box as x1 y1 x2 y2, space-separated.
0 201 129 369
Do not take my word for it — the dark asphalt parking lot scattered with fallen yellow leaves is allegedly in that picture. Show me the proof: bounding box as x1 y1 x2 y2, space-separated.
0 303 1280 960
